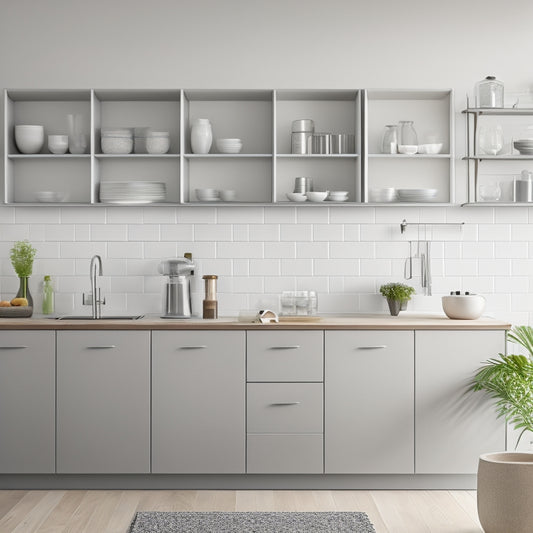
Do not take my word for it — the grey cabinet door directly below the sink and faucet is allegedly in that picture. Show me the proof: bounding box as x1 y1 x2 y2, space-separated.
57 331 150 474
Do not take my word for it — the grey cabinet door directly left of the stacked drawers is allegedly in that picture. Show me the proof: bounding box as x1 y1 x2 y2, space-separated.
152 331 245 474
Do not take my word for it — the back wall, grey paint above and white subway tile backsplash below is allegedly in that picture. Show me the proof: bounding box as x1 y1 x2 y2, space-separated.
0 0 533 323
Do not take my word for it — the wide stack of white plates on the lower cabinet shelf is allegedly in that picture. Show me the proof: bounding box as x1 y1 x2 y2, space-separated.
100 181 166 204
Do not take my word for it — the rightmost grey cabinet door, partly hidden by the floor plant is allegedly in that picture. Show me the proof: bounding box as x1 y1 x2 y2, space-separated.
415 331 505 474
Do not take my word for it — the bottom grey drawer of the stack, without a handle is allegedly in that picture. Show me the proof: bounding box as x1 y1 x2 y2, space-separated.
246 434 324 474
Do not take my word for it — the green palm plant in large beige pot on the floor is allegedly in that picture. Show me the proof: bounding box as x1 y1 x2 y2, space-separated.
470 326 533 533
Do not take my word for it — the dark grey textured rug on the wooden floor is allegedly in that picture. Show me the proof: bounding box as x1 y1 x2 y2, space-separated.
130 511 376 533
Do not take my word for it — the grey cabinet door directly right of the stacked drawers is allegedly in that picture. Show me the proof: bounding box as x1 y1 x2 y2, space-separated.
324 331 414 474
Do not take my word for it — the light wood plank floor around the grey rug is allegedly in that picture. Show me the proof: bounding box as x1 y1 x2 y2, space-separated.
0 490 482 533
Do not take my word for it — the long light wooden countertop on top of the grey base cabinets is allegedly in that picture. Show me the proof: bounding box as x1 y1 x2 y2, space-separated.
0 313 511 330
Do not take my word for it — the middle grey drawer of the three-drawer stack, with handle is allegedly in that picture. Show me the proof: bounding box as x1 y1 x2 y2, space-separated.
247 383 323 433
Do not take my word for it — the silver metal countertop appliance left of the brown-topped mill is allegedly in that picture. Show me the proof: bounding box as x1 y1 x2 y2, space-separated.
157 257 196 318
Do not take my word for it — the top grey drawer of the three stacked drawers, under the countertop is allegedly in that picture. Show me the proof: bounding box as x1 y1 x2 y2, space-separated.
247 331 324 381
